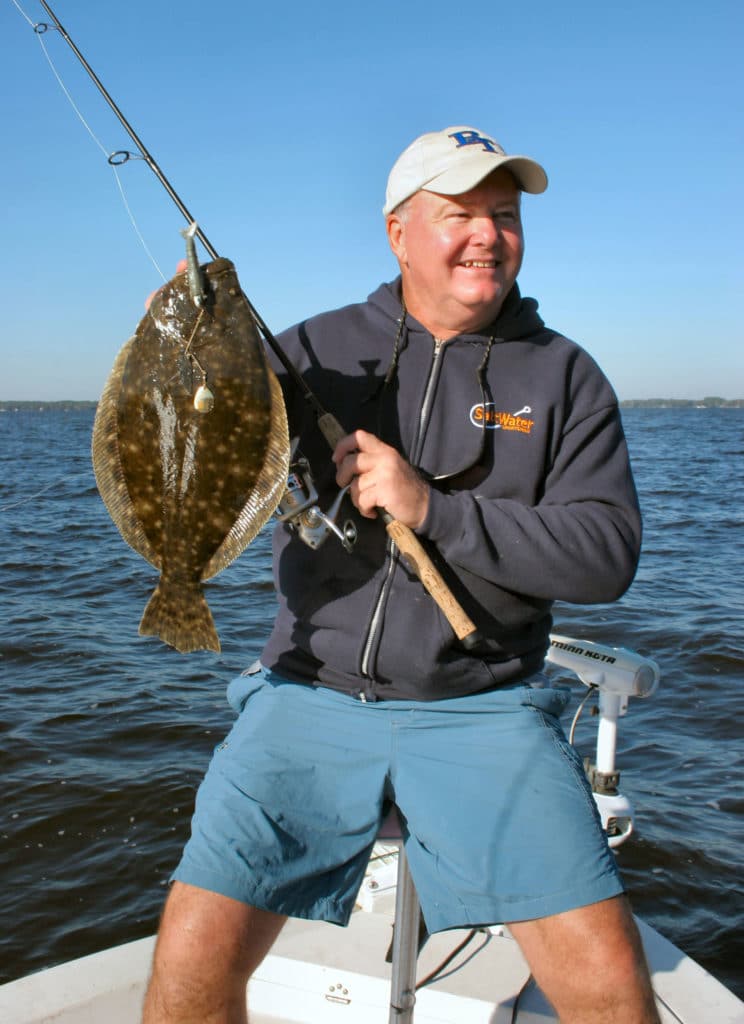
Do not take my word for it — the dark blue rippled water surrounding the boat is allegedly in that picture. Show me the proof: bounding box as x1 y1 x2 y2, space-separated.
0 409 744 997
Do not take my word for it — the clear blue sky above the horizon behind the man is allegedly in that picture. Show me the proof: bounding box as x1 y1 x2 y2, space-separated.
0 0 744 400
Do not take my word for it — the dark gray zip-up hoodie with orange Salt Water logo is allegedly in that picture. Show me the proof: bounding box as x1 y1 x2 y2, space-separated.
261 281 641 700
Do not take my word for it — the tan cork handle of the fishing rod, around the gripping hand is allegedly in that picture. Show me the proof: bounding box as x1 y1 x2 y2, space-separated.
317 413 481 650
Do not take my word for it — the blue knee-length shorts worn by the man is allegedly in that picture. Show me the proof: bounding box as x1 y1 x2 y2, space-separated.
173 670 622 933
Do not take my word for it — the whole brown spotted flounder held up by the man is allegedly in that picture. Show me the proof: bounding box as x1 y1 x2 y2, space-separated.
92 259 290 651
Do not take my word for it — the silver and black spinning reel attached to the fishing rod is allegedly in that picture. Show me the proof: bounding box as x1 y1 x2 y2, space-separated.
276 443 356 552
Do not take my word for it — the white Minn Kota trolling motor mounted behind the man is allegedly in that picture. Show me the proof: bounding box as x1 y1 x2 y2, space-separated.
546 633 661 848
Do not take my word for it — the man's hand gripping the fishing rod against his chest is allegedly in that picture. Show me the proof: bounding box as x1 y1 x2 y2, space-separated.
333 430 429 529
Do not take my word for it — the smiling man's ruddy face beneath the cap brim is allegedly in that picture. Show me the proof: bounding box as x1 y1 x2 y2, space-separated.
387 170 524 339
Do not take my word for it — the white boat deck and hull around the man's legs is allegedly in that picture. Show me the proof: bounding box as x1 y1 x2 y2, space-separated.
0 912 744 1024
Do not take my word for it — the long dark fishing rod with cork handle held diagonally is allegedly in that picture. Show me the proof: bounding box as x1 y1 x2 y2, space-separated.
29 0 480 648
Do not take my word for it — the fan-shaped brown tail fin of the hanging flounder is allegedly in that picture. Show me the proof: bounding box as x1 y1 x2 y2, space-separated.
139 580 220 654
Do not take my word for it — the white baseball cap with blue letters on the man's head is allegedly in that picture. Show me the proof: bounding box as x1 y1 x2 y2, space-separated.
383 125 548 217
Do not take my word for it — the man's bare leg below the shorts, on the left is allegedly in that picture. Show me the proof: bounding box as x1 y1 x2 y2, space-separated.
142 882 287 1024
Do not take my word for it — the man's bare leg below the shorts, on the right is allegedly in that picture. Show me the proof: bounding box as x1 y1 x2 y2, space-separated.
509 896 659 1024
